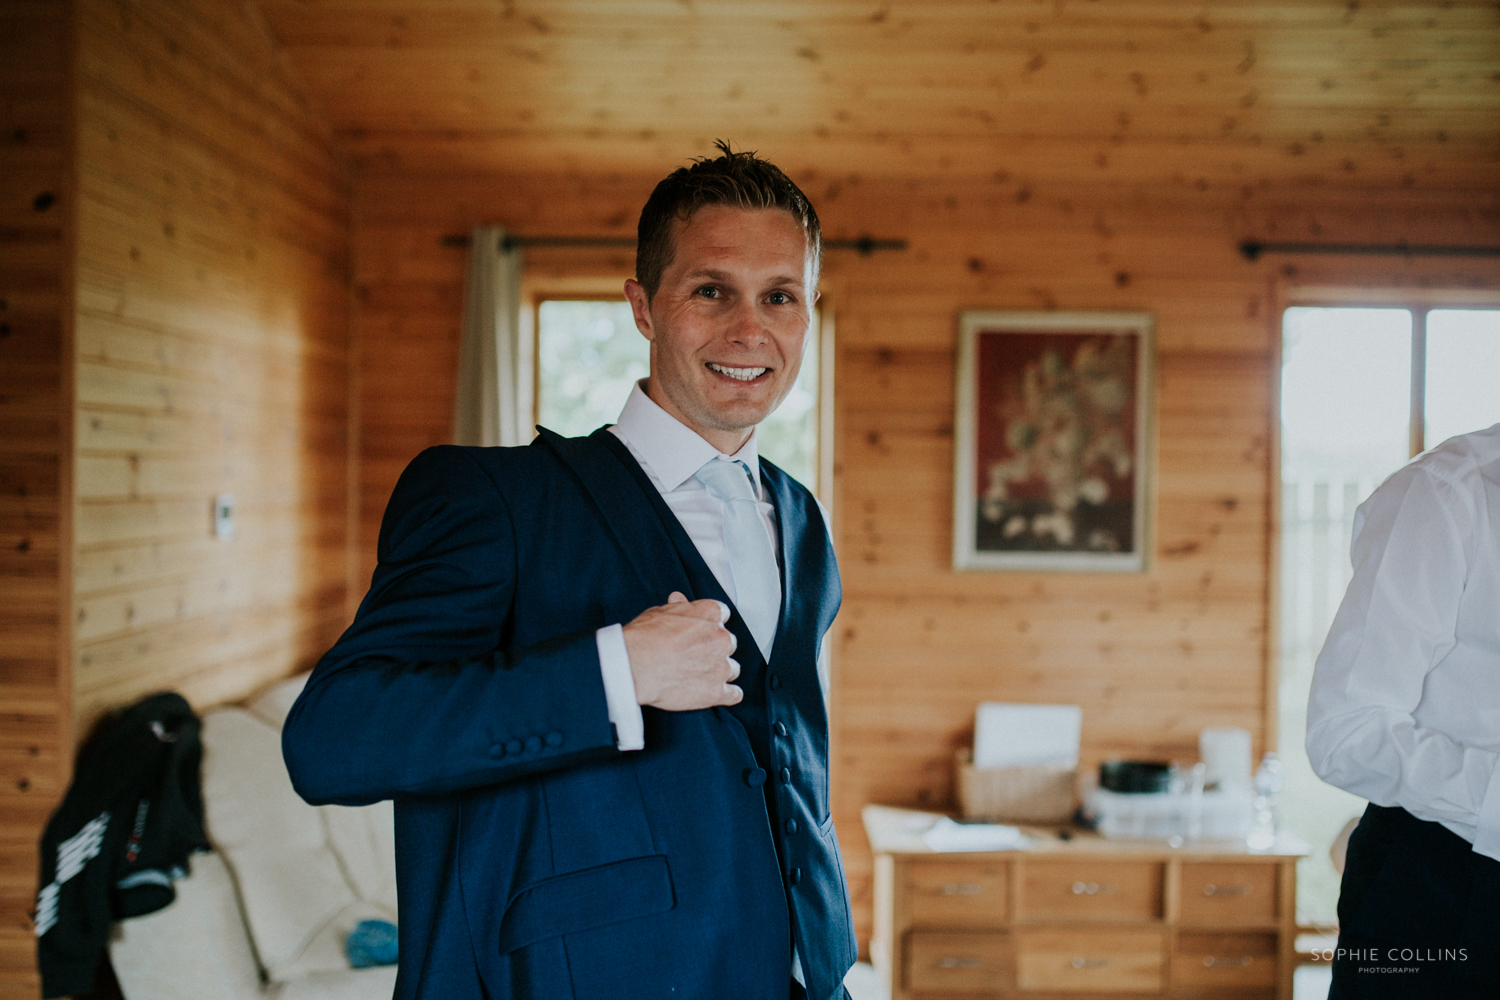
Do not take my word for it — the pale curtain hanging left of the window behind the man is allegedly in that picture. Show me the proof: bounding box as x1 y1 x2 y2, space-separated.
453 226 533 447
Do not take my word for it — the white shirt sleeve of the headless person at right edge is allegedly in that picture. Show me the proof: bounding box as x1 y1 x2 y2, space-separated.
1307 466 1500 858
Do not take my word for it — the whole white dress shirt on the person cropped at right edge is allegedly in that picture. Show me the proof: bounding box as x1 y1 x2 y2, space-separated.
1307 424 1500 859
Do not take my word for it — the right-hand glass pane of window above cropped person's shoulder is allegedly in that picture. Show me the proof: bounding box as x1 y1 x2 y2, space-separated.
1425 309 1500 448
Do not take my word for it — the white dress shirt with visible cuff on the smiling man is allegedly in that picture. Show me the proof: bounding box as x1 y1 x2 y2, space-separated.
596 384 779 750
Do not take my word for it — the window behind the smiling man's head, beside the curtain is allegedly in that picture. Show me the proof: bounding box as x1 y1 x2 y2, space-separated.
536 298 831 502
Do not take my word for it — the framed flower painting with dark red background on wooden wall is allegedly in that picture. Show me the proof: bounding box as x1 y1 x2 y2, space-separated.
953 312 1154 573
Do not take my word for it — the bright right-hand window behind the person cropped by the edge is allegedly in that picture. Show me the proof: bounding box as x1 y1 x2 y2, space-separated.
1278 307 1500 924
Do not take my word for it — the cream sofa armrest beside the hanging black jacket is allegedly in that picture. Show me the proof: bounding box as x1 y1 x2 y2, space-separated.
110 852 264 1000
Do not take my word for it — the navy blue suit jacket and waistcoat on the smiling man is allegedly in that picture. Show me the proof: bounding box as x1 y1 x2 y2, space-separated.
282 430 855 1000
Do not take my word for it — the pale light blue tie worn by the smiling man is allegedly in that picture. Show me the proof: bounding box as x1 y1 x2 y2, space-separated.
693 459 782 663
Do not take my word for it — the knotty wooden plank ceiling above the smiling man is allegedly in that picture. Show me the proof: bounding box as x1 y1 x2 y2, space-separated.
260 0 1500 193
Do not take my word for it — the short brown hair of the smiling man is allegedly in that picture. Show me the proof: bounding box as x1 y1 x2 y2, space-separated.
636 139 824 298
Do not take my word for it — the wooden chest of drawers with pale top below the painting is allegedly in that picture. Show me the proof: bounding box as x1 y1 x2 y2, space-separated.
864 805 1305 1000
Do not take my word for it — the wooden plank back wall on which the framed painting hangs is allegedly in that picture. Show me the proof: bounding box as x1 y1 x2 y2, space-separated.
354 174 1500 939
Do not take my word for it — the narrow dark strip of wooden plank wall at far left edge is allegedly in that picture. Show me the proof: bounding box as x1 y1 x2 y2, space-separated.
0 0 74 997
